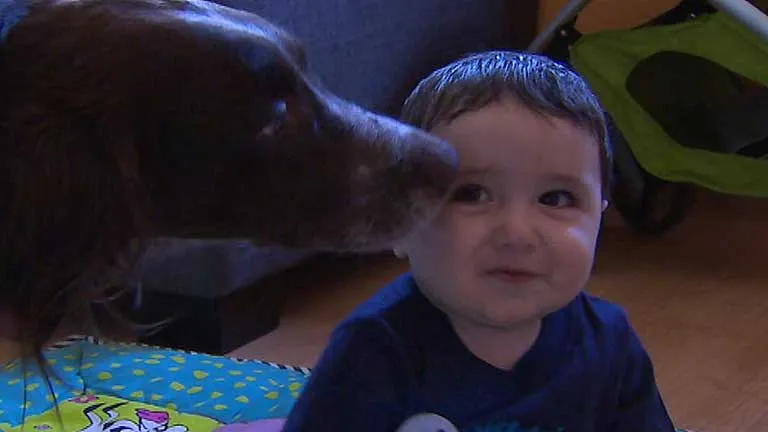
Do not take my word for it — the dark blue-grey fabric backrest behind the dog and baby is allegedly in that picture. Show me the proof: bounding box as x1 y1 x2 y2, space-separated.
213 0 536 115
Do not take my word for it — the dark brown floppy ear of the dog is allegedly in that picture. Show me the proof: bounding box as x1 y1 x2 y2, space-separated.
0 106 147 347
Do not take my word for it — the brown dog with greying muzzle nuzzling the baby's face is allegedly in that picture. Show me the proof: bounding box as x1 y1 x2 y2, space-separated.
0 0 457 349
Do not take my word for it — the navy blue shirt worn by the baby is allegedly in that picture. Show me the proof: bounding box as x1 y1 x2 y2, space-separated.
284 274 674 432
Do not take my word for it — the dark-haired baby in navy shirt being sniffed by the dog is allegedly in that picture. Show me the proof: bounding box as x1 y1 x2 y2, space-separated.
284 52 674 432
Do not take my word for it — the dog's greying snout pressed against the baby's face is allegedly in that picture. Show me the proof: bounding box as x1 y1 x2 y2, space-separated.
294 93 459 250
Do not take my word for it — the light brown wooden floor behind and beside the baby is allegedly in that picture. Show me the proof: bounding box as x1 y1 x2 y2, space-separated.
234 192 768 432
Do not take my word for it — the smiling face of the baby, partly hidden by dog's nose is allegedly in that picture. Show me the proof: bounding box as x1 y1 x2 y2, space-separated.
401 102 605 328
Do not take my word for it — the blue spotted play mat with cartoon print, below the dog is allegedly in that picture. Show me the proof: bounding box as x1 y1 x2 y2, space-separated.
0 338 309 432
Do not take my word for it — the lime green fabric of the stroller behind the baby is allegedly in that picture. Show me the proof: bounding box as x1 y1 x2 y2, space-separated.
570 12 768 197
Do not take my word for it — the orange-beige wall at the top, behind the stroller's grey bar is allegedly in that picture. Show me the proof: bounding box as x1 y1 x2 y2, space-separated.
536 0 679 33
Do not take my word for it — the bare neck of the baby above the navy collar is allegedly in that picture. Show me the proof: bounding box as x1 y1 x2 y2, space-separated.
451 318 541 371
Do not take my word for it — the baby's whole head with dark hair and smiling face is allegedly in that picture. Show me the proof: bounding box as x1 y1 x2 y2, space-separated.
396 52 611 328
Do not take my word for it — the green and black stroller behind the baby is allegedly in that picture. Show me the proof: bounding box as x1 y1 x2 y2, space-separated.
528 0 768 235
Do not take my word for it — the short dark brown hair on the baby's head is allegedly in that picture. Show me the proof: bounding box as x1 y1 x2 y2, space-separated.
401 51 612 199
